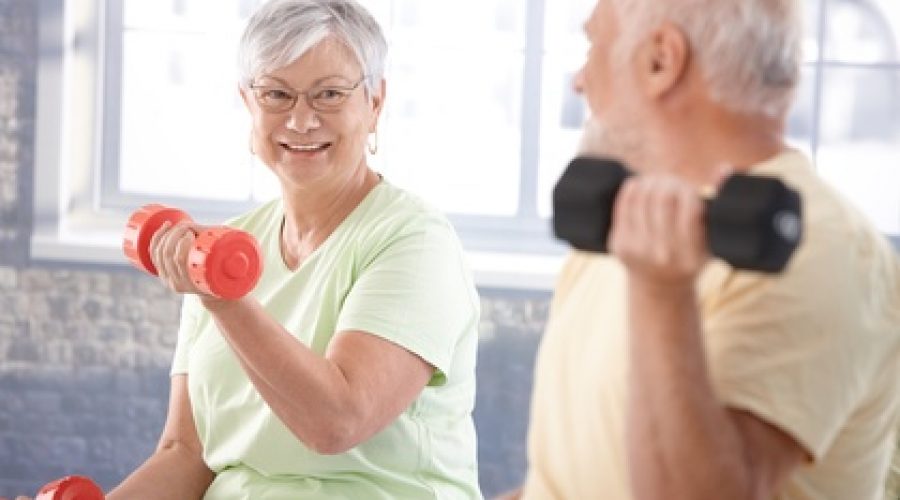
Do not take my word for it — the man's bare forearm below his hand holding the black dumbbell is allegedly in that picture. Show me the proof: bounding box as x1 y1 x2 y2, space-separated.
627 280 752 500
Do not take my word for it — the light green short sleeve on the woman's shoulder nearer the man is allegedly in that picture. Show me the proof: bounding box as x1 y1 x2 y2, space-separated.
336 217 478 385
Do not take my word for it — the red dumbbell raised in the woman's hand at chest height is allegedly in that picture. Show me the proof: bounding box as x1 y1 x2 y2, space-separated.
122 204 262 299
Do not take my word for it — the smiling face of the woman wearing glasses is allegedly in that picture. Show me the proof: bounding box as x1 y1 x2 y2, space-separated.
242 37 384 188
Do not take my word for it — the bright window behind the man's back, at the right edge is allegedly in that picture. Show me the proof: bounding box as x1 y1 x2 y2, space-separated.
813 0 900 237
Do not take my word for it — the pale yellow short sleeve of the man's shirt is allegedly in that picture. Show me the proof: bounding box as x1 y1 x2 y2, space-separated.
704 264 871 460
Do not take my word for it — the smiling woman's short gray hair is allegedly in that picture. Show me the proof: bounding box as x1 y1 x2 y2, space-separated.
238 0 387 93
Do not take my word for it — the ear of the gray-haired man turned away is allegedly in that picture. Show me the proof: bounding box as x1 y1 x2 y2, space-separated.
638 23 691 99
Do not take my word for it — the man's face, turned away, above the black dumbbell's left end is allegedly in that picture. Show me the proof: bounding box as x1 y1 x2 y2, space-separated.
575 0 642 162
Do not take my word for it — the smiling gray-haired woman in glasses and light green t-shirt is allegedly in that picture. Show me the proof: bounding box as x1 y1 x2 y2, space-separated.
108 0 481 500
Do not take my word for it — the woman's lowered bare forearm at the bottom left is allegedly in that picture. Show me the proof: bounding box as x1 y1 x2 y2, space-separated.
106 443 215 500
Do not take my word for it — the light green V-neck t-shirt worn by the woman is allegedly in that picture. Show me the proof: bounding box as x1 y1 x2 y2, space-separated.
172 181 481 500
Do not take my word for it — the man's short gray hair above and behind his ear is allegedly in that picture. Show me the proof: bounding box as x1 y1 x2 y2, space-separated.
614 0 803 116
